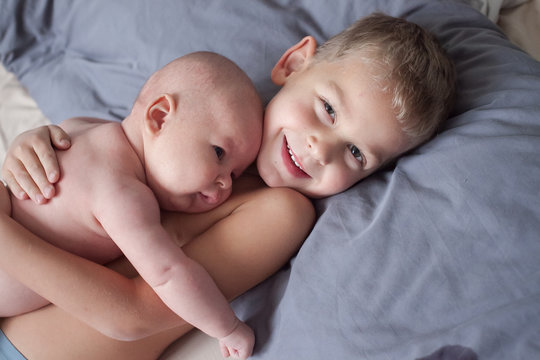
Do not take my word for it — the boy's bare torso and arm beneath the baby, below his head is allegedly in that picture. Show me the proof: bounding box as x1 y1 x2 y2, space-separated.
0 171 315 360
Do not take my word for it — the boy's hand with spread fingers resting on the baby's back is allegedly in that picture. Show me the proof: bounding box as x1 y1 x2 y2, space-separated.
2 125 71 204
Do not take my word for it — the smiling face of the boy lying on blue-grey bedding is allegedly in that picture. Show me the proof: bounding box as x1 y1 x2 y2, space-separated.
257 40 412 198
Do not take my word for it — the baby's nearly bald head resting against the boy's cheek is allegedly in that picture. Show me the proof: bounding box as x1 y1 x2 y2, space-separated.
132 52 262 212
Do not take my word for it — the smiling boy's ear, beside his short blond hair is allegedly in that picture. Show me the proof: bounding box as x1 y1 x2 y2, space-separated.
270 36 317 86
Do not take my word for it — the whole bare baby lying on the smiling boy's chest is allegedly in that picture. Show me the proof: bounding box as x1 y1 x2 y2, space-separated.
0 52 262 356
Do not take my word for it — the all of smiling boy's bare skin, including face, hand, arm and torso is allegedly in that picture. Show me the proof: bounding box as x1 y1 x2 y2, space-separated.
0 13 452 358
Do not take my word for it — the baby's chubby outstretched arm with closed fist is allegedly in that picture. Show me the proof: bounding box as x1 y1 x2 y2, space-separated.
93 177 254 358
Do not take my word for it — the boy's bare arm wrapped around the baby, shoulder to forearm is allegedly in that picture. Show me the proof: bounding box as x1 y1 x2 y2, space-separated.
0 178 314 340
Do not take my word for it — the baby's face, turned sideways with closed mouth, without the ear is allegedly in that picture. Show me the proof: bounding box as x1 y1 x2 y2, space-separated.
145 81 262 212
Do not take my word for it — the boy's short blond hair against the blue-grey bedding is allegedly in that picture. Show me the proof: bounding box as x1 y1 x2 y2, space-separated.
315 13 456 142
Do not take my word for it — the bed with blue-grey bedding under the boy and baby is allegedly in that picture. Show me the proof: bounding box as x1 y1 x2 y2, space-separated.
0 0 540 360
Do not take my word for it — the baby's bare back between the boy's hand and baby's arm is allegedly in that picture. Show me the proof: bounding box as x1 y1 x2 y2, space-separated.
11 120 142 263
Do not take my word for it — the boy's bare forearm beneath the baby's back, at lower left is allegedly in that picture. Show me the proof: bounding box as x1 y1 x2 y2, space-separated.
0 212 183 340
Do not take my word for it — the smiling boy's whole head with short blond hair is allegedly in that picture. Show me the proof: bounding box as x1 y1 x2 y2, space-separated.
257 14 455 197
